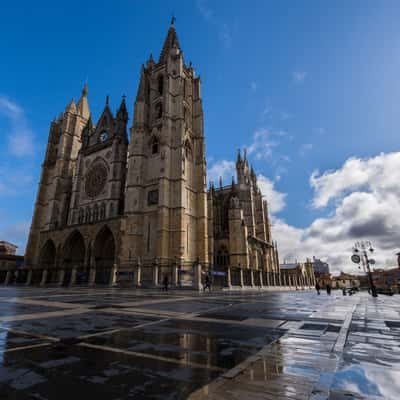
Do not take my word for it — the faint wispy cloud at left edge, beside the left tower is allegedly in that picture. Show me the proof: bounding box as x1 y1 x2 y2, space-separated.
0 95 34 157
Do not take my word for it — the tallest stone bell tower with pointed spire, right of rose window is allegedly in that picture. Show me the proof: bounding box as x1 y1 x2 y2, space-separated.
123 21 208 278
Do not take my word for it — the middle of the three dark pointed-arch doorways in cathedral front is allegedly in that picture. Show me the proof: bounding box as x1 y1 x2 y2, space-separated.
63 231 85 286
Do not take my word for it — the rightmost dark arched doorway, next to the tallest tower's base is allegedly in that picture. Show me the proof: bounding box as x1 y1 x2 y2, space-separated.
94 227 115 284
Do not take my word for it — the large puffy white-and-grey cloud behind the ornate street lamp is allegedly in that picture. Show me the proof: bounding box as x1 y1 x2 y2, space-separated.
273 153 400 273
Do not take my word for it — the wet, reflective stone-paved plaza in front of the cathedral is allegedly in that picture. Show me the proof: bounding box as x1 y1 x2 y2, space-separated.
0 287 400 400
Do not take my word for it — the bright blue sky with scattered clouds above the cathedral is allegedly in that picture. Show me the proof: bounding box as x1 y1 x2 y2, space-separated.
0 0 400 269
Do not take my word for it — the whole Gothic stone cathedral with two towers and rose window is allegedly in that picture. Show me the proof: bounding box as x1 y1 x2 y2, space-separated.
17 24 290 288
